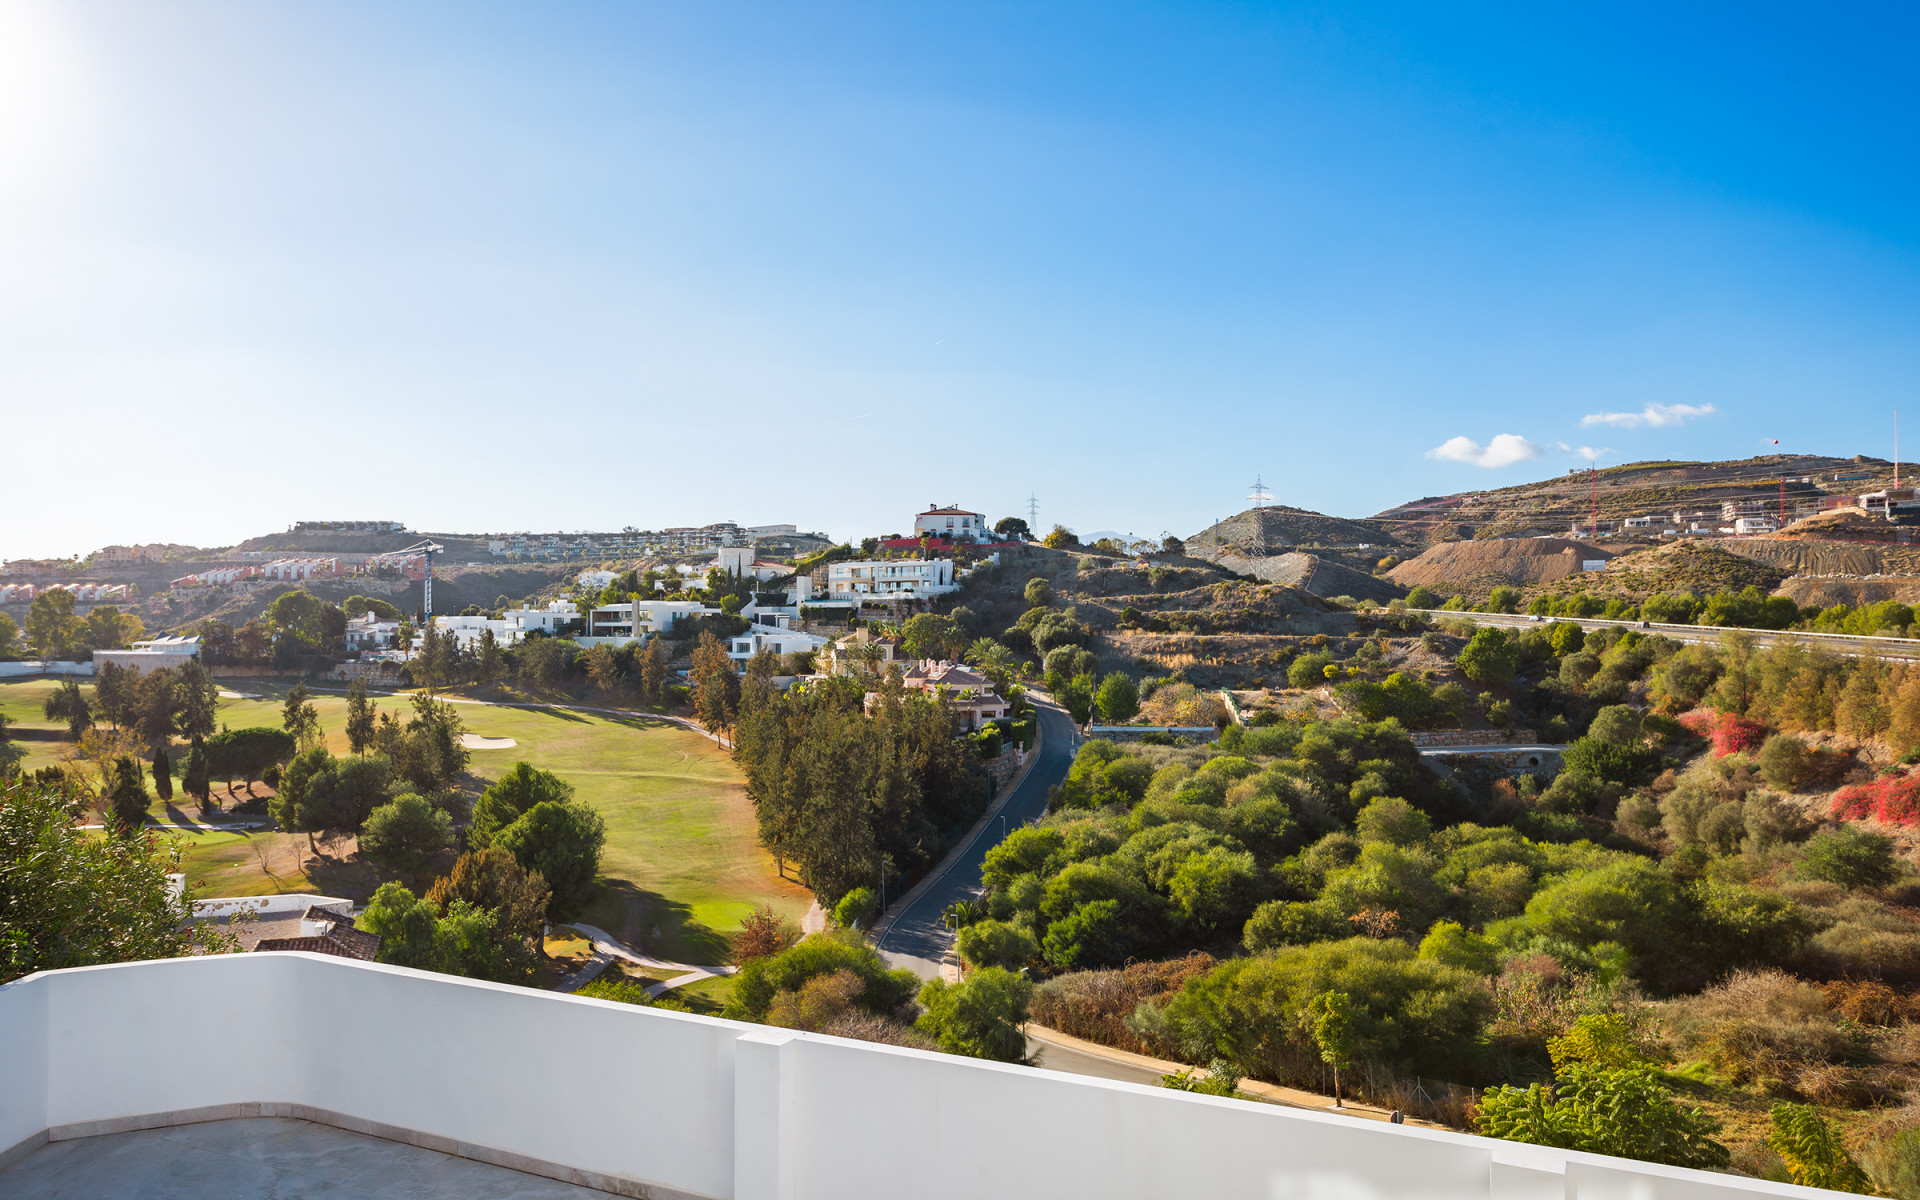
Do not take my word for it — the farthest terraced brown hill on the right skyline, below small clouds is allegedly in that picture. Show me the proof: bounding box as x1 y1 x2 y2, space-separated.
1371 455 1893 543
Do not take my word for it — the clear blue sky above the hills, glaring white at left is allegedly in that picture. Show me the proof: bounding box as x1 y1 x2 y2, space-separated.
0 0 1920 557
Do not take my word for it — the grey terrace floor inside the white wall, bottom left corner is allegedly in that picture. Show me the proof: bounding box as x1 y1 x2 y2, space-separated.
0 1117 609 1200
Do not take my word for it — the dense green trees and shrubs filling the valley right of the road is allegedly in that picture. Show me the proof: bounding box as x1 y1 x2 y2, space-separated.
956 612 1920 1194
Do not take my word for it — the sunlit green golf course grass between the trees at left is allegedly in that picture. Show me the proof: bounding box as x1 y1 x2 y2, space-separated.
0 680 810 962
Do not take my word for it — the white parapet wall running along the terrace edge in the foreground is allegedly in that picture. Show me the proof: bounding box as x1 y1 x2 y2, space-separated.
0 952 1822 1200
